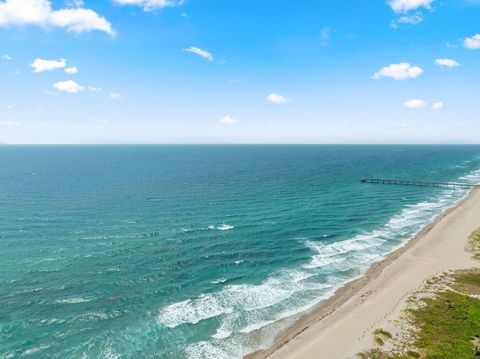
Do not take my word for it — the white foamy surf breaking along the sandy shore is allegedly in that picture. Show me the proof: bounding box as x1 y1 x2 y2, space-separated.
162 170 480 359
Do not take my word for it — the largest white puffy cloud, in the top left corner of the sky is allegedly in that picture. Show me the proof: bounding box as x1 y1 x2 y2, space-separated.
0 0 115 35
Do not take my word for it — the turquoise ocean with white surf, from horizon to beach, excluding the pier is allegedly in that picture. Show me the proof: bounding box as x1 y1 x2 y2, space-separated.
0 146 480 358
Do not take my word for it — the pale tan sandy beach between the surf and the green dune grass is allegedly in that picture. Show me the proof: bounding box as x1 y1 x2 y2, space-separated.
248 189 480 359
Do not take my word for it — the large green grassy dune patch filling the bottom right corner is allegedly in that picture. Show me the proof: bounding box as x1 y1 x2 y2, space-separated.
359 270 480 359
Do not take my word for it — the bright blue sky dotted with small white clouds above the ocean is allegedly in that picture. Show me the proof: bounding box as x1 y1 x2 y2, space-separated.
0 0 480 144
